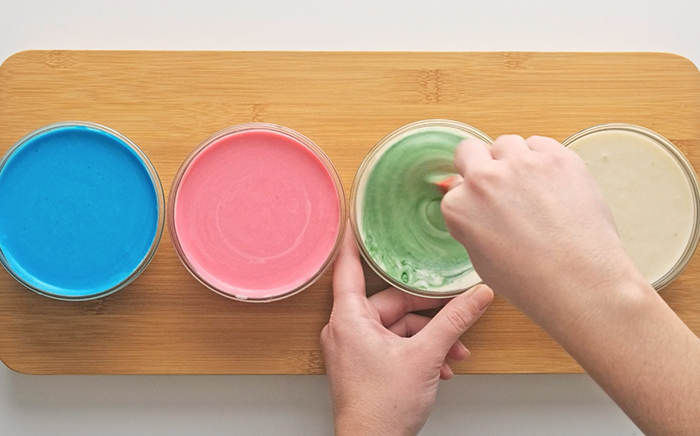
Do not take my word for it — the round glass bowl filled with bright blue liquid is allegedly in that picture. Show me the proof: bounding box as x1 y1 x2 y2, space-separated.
0 126 160 298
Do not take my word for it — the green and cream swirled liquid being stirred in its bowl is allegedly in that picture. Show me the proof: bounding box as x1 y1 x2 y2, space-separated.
358 128 479 294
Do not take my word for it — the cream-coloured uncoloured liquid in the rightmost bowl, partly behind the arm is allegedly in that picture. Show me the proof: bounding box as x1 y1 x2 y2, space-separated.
569 130 694 283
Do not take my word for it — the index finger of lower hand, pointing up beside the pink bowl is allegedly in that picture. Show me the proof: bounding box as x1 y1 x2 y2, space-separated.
333 225 365 304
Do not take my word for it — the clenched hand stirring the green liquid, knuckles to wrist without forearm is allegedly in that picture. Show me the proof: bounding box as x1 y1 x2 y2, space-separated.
442 135 644 318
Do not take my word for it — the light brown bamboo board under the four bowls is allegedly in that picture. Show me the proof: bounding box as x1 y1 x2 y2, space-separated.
0 51 700 374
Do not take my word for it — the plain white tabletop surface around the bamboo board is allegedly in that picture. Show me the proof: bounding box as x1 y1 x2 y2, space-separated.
0 0 700 436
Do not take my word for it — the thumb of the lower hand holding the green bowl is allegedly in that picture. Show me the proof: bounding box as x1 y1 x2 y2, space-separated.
416 285 493 356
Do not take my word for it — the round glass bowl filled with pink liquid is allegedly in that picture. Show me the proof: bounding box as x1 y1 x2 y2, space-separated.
174 130 340 299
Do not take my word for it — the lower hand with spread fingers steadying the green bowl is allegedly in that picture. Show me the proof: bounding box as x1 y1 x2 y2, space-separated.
321 233 493 436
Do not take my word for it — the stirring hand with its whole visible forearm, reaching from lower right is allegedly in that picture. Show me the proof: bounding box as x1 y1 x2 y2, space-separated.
442 136 700 435
